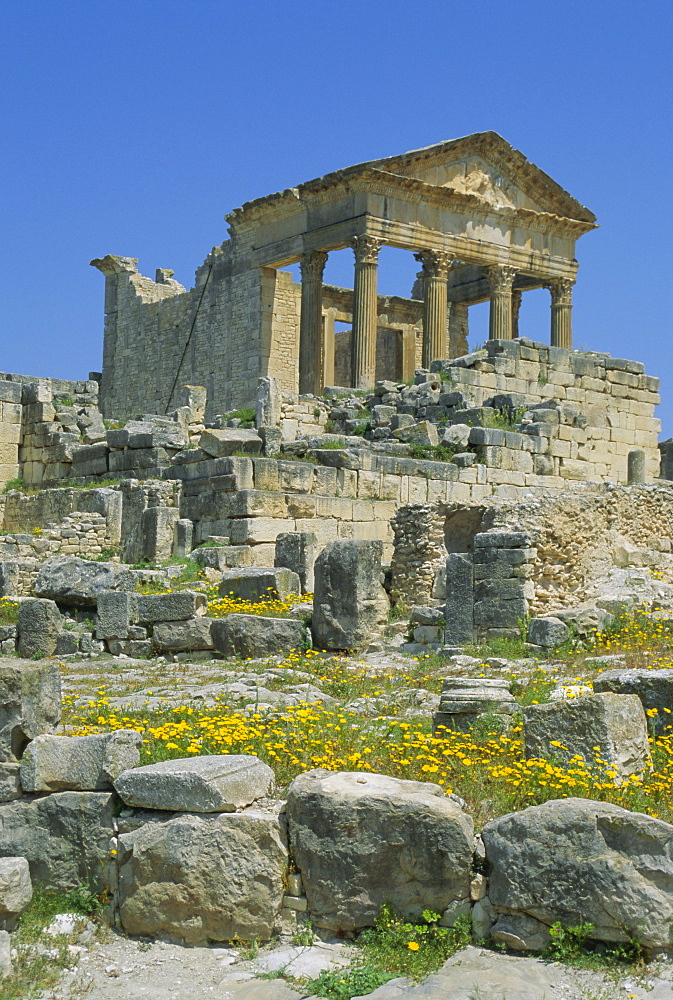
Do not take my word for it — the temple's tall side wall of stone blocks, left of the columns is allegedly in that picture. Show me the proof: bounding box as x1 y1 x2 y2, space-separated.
92 254 422 419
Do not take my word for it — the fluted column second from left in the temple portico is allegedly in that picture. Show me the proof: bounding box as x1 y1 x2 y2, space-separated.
351 234 381 389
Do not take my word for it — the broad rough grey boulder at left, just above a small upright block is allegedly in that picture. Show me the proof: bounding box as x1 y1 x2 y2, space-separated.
33 556 139 608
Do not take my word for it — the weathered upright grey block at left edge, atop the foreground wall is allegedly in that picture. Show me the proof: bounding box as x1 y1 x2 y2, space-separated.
0 661 61 761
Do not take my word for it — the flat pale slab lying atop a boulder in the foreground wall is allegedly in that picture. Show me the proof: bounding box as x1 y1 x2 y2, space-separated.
115 754 274 813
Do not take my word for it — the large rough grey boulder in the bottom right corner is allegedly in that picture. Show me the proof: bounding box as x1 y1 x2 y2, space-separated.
482 798 673 948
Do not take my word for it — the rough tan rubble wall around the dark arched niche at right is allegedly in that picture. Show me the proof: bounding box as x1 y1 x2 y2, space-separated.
391 481 673 632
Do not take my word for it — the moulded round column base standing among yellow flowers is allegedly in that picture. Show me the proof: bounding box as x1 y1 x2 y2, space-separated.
432 677 518 735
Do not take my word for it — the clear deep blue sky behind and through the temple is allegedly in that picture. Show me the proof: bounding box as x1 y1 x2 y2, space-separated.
0 0 673 437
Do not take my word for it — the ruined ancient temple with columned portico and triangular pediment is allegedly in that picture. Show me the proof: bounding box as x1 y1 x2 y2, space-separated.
92 132 596 417
